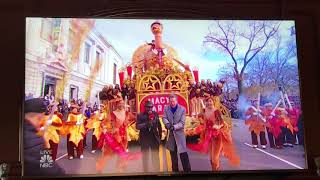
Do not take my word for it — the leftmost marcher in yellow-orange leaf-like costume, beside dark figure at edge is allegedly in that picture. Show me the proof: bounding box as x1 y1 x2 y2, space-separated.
39 103 63 161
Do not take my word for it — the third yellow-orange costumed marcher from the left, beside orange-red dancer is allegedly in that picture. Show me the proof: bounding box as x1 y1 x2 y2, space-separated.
86 104 107 153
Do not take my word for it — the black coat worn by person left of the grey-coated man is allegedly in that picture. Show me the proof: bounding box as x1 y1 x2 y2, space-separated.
136 111 162 147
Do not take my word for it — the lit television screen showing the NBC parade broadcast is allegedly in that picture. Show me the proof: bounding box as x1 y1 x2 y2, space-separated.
22 17 307 176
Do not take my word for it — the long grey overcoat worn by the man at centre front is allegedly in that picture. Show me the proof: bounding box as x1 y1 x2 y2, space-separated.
162 104 187 153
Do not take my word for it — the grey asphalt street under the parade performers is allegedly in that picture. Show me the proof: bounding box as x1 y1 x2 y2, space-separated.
56 120 306 175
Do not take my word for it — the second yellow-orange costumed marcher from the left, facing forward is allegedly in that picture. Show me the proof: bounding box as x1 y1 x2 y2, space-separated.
65 103 85 160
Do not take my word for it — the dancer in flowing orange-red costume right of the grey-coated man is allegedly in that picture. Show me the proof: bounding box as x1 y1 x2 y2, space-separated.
188 97 240 170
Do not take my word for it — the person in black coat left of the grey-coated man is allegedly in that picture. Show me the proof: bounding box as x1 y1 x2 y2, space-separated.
136 101 162 172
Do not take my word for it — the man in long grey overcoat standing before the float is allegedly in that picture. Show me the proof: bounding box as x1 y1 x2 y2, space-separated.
162 94 191 172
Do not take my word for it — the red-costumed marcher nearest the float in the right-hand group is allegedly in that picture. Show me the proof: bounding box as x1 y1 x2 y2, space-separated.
245 97 267 149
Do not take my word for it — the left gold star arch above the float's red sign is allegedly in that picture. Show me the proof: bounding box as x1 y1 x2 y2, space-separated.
138 75 161 91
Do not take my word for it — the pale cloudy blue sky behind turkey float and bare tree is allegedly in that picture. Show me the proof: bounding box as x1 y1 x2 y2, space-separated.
95 19 294 80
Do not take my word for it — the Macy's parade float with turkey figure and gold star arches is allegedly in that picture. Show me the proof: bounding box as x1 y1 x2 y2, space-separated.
100 21 231 141
